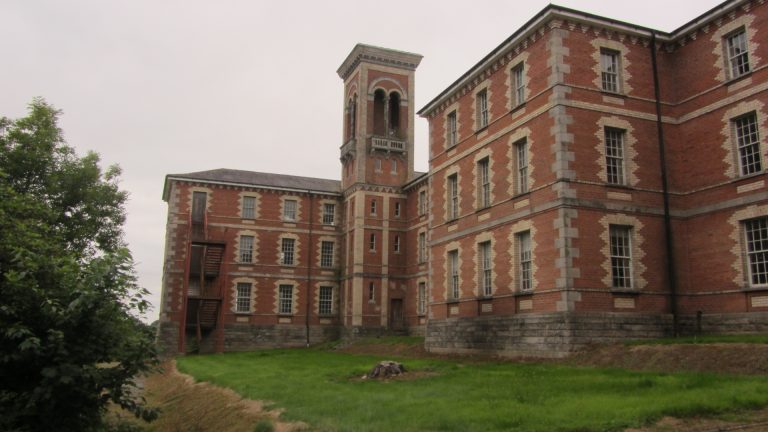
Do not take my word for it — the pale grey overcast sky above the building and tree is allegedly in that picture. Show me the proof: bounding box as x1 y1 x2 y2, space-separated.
0 0 720 321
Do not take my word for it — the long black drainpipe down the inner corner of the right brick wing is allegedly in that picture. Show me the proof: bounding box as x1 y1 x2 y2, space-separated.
651 32 680 337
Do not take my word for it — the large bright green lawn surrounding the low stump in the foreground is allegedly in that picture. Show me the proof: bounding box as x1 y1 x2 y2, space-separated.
177 349 768 432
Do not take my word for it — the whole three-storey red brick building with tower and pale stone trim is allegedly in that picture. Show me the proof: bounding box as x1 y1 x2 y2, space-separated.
159 0 768 355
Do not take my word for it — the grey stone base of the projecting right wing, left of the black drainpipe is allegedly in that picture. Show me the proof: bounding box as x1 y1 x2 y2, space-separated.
425 313 672 357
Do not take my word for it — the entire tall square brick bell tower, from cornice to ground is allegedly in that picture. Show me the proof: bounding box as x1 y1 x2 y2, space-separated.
336 44 421 332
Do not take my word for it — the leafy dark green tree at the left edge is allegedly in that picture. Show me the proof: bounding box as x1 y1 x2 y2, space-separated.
0 99 156 431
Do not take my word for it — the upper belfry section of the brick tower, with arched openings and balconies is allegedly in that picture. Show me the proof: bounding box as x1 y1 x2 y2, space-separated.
336 44 422 189
